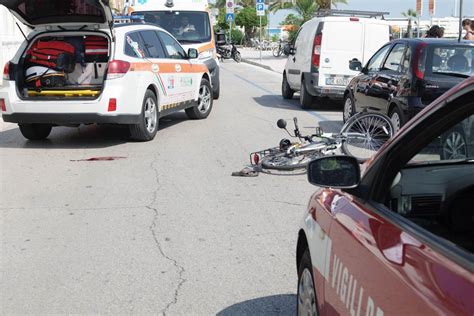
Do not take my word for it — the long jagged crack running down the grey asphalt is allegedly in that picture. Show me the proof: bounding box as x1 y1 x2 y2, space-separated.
146 161 186 315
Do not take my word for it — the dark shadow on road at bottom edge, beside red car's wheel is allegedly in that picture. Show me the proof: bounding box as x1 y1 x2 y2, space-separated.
217 294 296 316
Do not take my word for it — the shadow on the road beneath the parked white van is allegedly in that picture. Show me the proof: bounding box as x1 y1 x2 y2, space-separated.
253 95 343 112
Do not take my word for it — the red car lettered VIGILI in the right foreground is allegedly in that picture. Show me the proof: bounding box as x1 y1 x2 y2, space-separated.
296 77 474 316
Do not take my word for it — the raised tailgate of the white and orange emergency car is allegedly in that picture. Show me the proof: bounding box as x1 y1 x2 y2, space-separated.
0 0 113 29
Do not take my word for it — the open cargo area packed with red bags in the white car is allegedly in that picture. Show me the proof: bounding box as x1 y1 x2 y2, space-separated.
15 32 110 99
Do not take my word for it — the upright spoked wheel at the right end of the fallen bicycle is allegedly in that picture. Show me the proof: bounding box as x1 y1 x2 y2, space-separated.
341 113 394 160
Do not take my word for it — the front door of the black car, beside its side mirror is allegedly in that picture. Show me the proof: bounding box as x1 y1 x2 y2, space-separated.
353 44 391 112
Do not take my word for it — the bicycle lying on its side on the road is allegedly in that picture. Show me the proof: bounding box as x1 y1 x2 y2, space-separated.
250 112 394 171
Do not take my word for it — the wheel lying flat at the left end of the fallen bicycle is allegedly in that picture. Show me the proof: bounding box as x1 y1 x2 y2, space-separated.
262 151 321 171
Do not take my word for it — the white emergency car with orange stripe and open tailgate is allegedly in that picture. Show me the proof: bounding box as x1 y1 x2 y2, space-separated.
0 0 212 141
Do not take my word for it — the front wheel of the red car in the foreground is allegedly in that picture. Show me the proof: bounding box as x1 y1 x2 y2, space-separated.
296 249 319 316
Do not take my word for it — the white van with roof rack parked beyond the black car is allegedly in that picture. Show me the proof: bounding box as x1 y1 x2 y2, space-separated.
282 10 390 109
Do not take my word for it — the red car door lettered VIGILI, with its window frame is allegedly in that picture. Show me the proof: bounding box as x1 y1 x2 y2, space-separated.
321 90 474 315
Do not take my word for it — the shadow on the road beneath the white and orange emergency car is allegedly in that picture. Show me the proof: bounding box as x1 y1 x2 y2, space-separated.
0 112 188 149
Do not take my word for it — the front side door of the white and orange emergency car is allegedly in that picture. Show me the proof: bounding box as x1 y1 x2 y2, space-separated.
158 31 198 109
